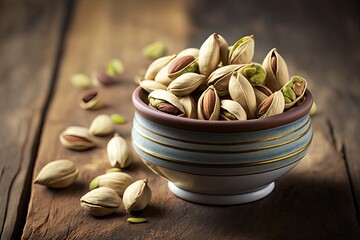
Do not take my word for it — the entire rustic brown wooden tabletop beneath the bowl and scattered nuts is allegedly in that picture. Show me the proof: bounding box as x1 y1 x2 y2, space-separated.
0 0 360 240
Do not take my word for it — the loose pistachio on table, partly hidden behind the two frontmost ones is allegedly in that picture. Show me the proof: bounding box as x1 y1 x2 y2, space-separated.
89 172 135 196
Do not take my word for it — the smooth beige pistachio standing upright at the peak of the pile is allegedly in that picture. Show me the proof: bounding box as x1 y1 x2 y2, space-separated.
199 33 220 77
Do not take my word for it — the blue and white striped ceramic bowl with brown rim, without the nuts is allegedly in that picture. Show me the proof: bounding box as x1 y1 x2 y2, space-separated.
131 87 313 205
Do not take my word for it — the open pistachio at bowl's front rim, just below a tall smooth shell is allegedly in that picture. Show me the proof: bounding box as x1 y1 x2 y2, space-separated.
220 99 247 120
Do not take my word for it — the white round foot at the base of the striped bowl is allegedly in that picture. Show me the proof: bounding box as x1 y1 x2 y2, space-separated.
168 182 275 205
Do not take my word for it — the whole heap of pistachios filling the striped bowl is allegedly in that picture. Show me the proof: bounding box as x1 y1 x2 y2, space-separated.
139 33 307 120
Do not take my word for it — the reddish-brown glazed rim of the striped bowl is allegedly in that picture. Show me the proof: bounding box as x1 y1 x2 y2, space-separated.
132 86 313 132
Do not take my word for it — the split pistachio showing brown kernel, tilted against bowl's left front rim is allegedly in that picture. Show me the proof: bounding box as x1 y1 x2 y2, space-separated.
148 89 185 117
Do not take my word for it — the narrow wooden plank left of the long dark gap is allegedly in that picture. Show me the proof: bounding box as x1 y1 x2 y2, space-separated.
0 1 66 239
